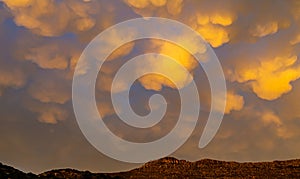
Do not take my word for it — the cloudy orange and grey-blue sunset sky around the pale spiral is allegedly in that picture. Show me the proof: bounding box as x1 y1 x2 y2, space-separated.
0 0 300 173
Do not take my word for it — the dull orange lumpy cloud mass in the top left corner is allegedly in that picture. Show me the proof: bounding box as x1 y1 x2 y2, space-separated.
3 0 99 36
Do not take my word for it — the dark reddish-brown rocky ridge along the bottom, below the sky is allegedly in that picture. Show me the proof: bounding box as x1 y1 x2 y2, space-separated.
0 157 300 178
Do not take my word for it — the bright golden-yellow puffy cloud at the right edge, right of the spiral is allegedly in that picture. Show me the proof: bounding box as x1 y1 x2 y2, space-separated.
232 56 300 100
